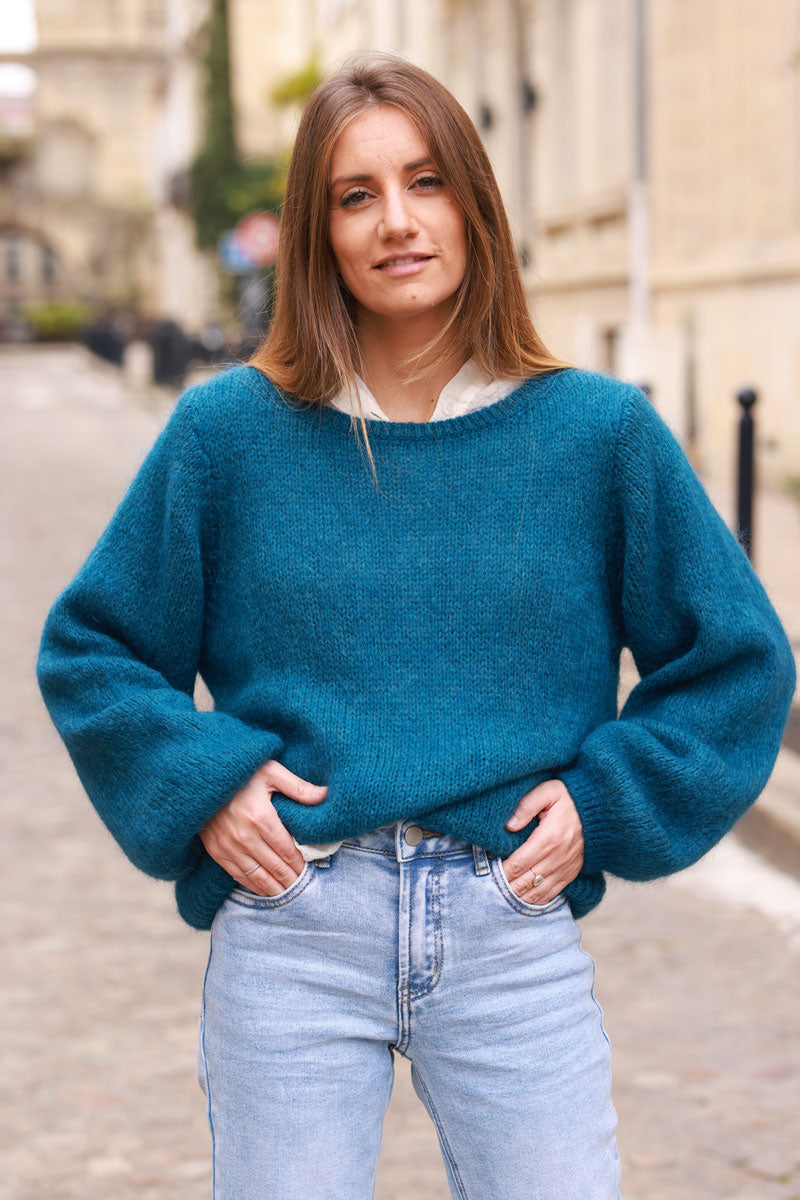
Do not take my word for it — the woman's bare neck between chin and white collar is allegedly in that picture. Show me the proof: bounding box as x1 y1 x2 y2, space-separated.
356 313 469 421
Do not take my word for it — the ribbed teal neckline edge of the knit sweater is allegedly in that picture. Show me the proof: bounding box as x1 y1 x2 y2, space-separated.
246 366 570 442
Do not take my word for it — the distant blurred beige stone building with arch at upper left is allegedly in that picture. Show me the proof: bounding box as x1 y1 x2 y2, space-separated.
0 0 217 324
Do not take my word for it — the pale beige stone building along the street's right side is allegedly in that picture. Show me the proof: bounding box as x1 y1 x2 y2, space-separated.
231 0 800 484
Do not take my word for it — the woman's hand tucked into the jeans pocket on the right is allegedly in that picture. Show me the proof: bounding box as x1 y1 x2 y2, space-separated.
501 779 583 904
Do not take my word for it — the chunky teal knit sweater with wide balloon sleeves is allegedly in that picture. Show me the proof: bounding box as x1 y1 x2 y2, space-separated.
38 367 795 929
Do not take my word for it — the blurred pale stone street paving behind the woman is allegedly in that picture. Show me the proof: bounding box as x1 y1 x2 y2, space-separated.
0 348 800 1200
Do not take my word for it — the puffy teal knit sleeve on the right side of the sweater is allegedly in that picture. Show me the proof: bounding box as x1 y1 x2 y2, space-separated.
558 388 795 880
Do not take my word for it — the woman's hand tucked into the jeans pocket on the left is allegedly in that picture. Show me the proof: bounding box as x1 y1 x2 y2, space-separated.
200 758 327 896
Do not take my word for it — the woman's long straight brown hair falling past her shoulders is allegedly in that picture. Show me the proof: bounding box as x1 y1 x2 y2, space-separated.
248 54 572 469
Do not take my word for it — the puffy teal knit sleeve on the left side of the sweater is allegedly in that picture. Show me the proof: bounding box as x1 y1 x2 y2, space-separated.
37 392 282 878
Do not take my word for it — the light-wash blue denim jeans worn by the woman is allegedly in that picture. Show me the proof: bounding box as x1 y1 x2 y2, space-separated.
198 821 619 1200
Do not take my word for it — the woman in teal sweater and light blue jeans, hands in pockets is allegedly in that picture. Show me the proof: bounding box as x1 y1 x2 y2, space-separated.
40 55 794 1200
